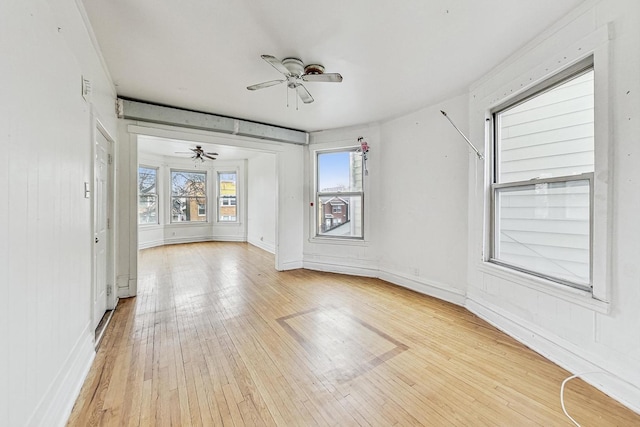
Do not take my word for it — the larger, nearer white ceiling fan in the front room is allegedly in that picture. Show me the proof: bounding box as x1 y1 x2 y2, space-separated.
247 55 342 104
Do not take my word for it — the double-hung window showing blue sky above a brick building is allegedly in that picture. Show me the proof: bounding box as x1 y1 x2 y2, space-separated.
316 148 364 239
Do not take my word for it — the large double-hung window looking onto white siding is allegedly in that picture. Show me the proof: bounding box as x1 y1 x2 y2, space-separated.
491 59 595 289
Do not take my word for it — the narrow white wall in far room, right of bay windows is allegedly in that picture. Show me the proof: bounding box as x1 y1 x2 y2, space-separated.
247 154 276 253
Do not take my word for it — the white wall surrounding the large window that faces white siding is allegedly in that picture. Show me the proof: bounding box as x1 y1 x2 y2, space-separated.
467 0 640 411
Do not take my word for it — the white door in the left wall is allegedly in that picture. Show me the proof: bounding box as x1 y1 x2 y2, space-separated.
92 129 111 329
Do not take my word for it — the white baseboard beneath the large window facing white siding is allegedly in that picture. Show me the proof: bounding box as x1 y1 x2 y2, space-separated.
465 295 640 413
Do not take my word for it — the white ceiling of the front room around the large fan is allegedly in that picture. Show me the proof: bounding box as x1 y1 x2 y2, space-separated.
83 0 583 131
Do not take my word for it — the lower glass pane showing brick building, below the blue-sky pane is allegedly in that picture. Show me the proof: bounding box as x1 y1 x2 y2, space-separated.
318 194 362 237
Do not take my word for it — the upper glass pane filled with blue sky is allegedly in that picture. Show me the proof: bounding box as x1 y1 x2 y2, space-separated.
318 150 362 193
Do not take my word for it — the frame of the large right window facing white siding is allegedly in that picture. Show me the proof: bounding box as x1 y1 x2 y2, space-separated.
487 56 599 292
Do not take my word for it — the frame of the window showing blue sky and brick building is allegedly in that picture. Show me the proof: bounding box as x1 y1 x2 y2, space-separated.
313 146 366 241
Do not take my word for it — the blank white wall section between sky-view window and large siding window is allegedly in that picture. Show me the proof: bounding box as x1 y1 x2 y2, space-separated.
378 95 468 304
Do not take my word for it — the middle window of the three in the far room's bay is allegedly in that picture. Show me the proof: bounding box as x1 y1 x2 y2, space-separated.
171 170 207 222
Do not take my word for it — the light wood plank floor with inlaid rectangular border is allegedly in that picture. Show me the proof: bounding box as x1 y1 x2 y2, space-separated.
69 243 640 427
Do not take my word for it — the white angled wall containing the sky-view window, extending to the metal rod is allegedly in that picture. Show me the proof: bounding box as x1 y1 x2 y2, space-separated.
304 99 476 304
